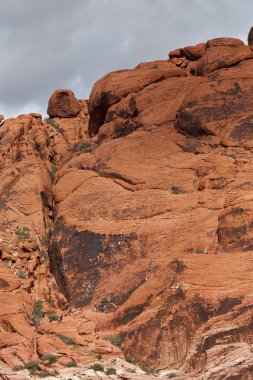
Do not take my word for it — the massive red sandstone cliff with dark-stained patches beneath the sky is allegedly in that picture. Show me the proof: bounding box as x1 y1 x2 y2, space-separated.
0 38 253 380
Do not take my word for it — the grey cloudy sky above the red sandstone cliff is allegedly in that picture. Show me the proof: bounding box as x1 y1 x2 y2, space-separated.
0 0 253 117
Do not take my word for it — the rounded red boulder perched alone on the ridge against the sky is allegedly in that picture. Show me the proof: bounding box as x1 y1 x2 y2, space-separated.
47 90 81 118
